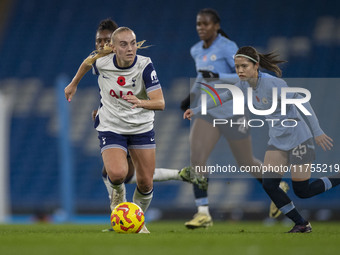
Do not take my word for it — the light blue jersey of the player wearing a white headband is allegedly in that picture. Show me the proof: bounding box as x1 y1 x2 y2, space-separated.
193 72 324 151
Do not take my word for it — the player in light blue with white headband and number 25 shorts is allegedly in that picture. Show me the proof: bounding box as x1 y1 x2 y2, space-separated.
183 46 340 233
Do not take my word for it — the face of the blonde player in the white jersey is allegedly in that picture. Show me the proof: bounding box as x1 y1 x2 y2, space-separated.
112 31 137 67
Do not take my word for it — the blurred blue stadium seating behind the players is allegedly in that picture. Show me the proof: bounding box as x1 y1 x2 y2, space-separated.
0 0 340 222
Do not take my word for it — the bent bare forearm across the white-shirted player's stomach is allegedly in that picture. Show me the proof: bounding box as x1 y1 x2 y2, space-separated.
122 88 165 111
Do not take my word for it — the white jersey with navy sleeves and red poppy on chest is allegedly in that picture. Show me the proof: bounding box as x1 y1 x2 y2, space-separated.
93 53 161 135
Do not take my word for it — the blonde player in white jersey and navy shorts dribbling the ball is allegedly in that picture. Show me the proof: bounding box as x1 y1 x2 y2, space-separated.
65 27 165 233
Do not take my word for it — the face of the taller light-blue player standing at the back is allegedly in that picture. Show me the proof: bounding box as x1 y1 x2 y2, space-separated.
196 14 220 41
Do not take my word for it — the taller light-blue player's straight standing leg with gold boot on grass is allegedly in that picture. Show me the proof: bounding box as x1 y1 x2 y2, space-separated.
185 118 220 228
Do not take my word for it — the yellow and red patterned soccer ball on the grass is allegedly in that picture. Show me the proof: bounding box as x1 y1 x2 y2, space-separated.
111 202 144 233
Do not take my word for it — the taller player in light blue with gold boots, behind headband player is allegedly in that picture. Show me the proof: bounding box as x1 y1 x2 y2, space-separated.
181 9 261 228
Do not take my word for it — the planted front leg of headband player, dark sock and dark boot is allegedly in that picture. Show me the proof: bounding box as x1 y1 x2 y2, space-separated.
262 150 311 233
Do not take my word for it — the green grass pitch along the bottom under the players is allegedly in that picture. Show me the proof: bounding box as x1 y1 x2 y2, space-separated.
0 221 340 255
